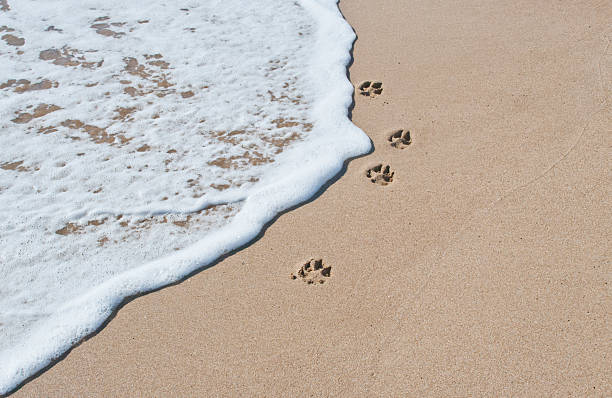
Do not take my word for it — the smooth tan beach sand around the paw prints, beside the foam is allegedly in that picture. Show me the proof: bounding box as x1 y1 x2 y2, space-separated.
10 0 612 397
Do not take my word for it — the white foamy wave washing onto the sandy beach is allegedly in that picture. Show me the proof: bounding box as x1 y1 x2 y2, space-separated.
0 0 370 393
